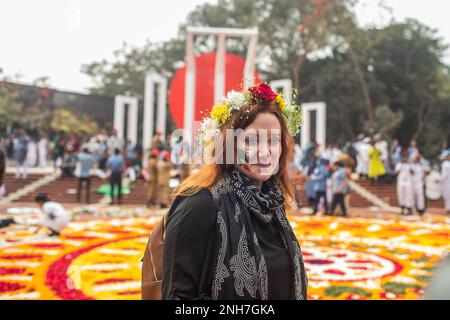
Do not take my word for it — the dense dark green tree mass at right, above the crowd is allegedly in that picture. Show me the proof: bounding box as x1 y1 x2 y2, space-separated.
301 20 450 155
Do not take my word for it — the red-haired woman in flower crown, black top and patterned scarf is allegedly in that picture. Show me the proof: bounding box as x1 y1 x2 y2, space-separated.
162 83 307 300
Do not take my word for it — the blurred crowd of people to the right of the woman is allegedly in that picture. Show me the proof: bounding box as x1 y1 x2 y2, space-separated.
292 134 450 215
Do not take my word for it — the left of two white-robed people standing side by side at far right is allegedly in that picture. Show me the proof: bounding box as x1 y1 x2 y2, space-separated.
395 155 414 215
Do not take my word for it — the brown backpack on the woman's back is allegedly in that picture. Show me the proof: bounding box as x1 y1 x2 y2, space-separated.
141 213 168 300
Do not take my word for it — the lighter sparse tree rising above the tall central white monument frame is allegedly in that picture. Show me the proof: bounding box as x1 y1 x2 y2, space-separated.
186 0 356 89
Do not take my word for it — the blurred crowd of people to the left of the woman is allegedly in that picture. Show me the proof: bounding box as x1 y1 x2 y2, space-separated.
0 128 190 208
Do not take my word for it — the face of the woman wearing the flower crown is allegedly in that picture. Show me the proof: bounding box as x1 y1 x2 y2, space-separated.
235 113 282 186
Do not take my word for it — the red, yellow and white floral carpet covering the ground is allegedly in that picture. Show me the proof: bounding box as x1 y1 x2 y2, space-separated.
0 209 450 299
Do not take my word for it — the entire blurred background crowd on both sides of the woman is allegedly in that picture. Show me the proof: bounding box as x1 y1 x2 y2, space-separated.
0 128 450 215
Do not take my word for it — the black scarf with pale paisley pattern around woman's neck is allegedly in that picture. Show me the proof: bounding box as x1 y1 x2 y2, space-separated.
211 169 307 300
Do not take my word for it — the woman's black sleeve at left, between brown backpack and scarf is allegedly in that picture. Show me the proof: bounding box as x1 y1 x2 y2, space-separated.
162 189 217 300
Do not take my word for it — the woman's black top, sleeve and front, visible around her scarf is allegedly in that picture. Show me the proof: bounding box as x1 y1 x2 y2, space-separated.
162 189 294 300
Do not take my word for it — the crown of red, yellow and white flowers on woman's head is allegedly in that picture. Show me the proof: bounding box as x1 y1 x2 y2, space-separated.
198 83 302 147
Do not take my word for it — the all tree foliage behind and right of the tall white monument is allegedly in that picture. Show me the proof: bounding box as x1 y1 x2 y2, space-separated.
83 0 450 158
